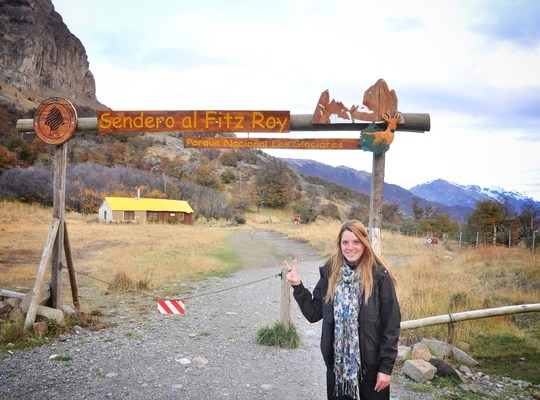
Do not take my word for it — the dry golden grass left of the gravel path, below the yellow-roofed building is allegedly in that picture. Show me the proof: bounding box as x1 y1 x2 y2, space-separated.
0 202 237 310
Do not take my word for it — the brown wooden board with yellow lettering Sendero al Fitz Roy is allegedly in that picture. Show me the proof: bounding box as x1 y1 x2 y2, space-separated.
98 110 291 133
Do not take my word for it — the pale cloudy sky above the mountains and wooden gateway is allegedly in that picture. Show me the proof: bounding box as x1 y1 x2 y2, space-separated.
53 0 540 201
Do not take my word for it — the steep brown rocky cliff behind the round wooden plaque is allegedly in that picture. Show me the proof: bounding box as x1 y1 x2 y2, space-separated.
0 0 105 133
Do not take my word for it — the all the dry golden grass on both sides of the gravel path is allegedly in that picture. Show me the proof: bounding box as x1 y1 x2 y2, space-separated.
4 202 540 346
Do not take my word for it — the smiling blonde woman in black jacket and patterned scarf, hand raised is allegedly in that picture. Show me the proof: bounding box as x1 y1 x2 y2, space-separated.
285 220 401 400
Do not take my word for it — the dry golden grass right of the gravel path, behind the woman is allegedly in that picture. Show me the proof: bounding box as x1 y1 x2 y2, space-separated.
248 210 540 341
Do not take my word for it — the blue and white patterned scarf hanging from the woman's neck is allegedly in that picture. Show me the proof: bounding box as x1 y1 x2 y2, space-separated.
334 264 362 399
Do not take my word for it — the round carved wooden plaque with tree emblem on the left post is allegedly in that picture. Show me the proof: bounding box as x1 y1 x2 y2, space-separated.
34 97 77 144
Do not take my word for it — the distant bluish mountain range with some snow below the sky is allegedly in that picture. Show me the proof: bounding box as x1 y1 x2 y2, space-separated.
281 158 540 222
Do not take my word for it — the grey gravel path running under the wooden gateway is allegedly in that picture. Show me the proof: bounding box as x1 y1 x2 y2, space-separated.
0 230 532 400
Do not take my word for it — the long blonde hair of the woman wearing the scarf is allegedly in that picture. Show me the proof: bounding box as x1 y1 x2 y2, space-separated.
325 219 396 303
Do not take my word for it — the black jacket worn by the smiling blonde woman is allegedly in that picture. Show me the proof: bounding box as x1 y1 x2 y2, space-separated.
293 263 401 375
